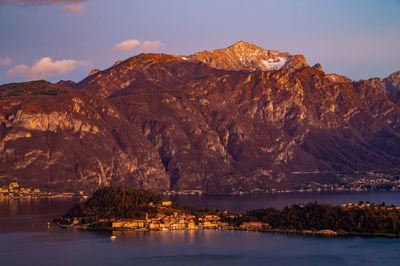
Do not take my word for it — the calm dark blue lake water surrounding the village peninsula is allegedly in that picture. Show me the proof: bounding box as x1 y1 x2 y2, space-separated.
0 192 400 266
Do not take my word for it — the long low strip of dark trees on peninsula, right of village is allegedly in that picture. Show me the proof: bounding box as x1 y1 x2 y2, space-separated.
232 202 400 235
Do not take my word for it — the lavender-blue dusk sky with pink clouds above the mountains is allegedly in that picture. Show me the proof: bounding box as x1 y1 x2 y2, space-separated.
0 0 400 84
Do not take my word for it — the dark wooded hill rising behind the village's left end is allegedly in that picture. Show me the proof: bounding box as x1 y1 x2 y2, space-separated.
64 187 162 221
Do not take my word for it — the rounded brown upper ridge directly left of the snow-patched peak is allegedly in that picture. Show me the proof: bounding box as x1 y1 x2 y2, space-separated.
72 53 227 97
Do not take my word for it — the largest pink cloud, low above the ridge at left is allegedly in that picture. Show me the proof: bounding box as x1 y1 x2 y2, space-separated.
7 57 90 80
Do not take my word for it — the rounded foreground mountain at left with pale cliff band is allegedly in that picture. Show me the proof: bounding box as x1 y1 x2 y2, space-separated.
0 81 169 191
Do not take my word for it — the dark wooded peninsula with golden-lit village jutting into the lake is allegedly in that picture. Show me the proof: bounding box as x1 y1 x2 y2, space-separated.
54 187 400 237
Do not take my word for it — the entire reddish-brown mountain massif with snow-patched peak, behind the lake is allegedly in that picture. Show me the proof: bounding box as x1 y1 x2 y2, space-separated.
0 42 400 193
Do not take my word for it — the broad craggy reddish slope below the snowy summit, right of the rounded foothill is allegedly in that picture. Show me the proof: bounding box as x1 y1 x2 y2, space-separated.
110 68 400 192
